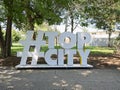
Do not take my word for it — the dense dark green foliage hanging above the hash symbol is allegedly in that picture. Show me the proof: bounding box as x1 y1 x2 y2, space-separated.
11 0 71 29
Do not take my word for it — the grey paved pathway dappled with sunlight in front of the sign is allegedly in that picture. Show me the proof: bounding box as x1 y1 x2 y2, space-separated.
0 67 120 90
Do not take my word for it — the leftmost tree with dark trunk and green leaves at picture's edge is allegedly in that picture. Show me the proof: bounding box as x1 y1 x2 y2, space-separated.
0 0 20 57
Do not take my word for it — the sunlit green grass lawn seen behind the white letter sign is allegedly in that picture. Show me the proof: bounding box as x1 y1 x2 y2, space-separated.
11 43 114 55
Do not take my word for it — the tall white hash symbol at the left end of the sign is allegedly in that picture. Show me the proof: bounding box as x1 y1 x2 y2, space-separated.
17 31 45 65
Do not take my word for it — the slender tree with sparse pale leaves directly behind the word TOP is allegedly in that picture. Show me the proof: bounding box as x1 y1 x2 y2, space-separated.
63 0 88 32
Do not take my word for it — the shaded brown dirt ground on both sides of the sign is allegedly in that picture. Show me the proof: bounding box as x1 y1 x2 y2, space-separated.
0 54 120 69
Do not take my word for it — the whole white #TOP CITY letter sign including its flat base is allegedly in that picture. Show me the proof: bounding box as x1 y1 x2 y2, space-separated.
16 31 92 68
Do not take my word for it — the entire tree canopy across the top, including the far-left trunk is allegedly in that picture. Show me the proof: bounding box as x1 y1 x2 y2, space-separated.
0 0 120 56
